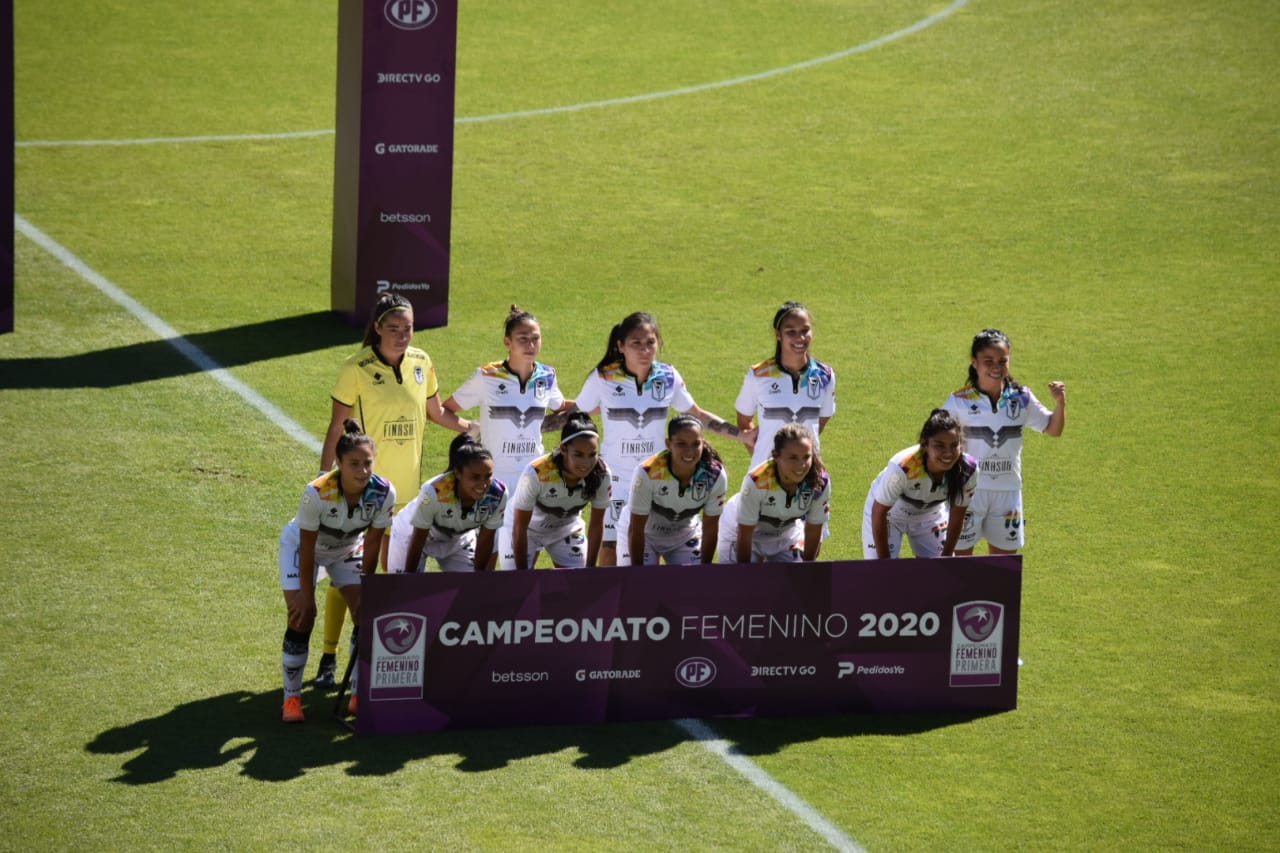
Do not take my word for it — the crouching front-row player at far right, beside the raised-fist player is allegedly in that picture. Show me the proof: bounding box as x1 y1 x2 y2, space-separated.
863 409 978 560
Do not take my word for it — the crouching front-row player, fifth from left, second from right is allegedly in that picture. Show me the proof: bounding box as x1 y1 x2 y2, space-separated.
719 424 831 562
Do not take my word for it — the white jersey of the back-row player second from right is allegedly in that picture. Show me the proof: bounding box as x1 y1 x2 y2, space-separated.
733 359 836 467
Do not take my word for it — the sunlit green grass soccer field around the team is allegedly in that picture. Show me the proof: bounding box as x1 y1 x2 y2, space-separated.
0 0 1280 850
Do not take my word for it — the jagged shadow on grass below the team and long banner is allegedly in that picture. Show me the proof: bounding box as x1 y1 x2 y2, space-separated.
86 689 989 785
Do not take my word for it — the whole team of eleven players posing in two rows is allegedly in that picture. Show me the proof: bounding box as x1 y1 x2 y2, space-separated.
280 295 1066 722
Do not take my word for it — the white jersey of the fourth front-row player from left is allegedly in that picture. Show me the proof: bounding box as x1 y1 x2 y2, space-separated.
627 451 728 540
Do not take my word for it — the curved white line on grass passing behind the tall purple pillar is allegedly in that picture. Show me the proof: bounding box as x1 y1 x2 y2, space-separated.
14 0 969 149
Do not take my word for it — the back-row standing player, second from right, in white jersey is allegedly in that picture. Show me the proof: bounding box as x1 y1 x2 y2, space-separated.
733 302 836 467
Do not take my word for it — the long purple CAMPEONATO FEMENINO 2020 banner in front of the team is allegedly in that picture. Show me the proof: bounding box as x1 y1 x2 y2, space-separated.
356 555 1021 734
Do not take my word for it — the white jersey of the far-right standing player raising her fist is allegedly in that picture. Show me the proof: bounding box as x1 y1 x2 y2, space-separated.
942 384 1053 492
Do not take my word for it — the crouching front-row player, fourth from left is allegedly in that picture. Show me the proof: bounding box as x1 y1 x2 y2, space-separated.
618 415 728 566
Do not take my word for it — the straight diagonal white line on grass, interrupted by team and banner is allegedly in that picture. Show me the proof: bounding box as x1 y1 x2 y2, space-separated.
13 214 863 853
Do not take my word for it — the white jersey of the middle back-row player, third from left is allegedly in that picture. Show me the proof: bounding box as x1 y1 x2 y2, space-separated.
575 361 695 491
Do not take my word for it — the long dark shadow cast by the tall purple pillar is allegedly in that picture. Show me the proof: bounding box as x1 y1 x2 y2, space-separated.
0 311 360 388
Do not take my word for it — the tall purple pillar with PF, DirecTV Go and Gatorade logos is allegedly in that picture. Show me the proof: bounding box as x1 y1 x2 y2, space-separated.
332 0 458 328
